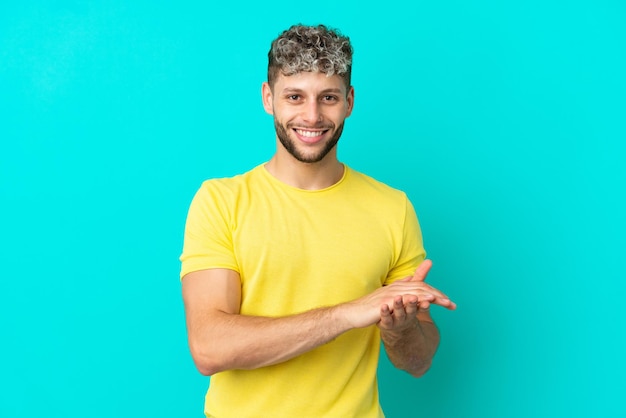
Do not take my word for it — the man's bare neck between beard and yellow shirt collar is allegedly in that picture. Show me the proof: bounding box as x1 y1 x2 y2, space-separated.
265 152 344 190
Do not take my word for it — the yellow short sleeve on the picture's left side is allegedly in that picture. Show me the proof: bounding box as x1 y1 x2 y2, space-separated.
180 180 239 279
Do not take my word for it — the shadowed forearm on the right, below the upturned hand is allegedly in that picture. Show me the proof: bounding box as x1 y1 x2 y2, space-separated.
381 319 439 377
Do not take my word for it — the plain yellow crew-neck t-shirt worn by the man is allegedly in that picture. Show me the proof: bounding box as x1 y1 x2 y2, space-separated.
181 165 425 418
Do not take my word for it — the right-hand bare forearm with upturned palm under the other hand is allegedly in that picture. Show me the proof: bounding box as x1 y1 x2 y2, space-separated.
379 260 456 377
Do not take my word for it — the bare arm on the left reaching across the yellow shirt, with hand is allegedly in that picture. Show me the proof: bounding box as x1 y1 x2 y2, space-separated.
183 269 428 375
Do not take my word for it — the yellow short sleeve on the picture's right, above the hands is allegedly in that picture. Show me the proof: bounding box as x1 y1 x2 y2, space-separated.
384 198 426 285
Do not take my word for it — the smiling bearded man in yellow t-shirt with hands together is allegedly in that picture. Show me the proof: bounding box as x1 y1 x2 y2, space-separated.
181 25 456 418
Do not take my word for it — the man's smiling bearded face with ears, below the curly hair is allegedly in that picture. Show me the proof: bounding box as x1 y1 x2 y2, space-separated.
263 72 354 163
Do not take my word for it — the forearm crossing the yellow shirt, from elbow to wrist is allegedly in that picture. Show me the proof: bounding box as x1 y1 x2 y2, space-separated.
189 306 351 375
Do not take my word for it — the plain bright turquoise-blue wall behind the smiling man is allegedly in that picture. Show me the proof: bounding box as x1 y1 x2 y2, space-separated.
0 0 626 418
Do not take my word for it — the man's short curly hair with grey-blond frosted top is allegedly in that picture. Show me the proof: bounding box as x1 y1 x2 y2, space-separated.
267 25 353 87
